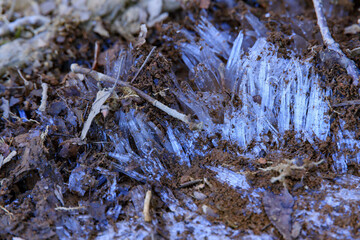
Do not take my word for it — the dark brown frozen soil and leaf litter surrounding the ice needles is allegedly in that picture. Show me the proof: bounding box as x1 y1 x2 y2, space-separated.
0 1 360 239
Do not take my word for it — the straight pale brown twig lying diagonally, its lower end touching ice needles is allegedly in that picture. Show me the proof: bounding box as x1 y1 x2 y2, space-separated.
71 63 202 130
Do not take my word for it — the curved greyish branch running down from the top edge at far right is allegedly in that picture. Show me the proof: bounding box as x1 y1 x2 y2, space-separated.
313 0 360 86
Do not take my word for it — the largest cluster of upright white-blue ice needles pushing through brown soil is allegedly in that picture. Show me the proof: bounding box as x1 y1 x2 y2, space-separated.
177 15 330 152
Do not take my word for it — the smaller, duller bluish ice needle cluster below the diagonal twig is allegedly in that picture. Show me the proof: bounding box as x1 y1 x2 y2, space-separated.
110 110 196 182
